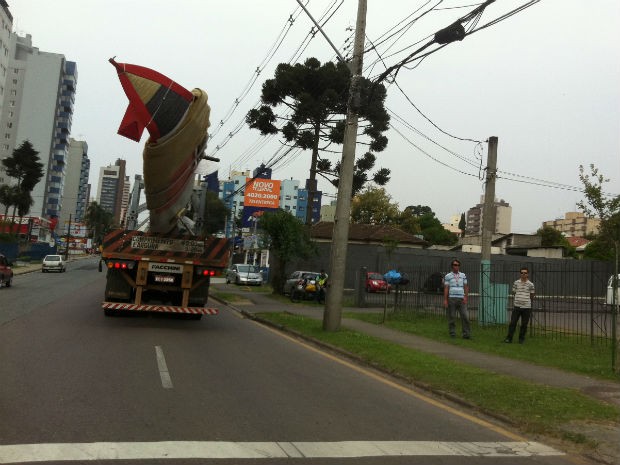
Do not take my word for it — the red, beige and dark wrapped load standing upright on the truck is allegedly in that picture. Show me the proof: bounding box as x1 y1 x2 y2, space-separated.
110 58 210 233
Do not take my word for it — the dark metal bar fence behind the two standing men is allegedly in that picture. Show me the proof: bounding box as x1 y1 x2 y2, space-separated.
355 257 618 345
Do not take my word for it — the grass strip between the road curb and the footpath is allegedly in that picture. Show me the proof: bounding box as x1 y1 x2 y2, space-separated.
260 313 620 442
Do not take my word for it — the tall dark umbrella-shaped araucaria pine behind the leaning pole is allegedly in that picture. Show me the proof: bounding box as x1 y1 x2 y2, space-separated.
246 58 390 224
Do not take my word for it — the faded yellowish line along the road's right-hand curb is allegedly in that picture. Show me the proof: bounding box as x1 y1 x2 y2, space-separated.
254 321 527 442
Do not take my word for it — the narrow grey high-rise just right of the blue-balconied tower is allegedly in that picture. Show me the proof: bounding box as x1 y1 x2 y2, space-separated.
59 138 90 225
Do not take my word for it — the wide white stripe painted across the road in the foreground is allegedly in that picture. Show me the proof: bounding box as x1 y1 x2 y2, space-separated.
0 441 565 464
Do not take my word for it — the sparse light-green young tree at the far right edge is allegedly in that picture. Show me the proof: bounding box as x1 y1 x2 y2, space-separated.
577 165 620 260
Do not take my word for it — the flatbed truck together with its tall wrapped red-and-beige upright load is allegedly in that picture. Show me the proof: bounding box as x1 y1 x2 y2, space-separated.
101 58 230 319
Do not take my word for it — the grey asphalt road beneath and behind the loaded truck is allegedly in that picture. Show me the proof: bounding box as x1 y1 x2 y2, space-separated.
0 259 574 465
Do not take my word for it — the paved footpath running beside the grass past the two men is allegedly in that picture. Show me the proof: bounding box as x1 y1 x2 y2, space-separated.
212 284 620 465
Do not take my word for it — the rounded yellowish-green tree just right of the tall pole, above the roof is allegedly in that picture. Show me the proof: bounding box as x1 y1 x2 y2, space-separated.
351 187 400 224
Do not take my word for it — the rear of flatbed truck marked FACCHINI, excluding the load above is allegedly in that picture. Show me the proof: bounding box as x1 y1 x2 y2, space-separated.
101 229 230 319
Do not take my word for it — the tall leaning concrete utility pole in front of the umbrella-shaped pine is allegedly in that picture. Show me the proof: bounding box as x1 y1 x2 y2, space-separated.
323 0 367 331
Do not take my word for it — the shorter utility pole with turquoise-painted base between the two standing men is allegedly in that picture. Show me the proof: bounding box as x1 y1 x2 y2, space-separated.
479 136 497 322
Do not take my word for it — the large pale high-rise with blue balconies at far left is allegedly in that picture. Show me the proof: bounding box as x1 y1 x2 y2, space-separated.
0 27 77 218
